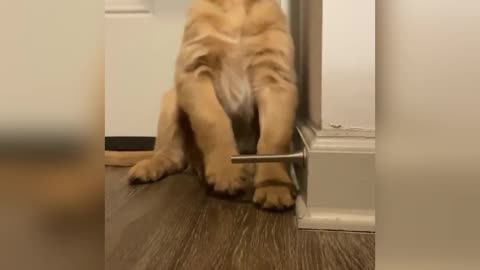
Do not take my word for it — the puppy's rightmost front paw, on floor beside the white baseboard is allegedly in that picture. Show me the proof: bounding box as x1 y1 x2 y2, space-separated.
253 184 295 210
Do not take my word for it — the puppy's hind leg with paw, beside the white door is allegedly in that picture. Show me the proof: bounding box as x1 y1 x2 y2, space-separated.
128 90 185 183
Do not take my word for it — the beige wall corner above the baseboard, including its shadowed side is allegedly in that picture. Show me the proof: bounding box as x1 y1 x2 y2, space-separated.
291 0 375 131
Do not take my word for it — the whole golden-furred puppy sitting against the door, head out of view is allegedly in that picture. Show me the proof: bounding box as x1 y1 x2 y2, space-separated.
106 0 297 209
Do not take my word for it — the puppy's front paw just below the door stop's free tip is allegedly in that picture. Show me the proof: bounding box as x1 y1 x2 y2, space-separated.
206 164 248 195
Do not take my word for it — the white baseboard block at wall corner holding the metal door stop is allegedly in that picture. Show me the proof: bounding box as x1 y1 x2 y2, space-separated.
295 125 375 232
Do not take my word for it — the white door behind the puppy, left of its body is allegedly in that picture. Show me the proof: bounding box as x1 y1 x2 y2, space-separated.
105 0 191 136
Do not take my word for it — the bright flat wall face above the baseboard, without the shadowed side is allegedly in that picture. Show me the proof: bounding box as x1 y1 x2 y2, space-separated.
321 0 375 130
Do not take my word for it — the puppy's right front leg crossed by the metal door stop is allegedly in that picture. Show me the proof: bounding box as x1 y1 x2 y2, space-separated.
249 65 297 210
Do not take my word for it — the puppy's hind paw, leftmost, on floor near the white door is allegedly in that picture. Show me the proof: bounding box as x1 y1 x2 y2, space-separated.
128 159 172 184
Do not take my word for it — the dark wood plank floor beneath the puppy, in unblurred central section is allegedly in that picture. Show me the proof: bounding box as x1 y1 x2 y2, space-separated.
105 168 375 270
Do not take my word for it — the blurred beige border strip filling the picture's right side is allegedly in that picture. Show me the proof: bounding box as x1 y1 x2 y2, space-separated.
375 0 480 270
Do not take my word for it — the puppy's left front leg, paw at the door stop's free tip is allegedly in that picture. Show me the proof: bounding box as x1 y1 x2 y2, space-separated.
178 74 246 195
